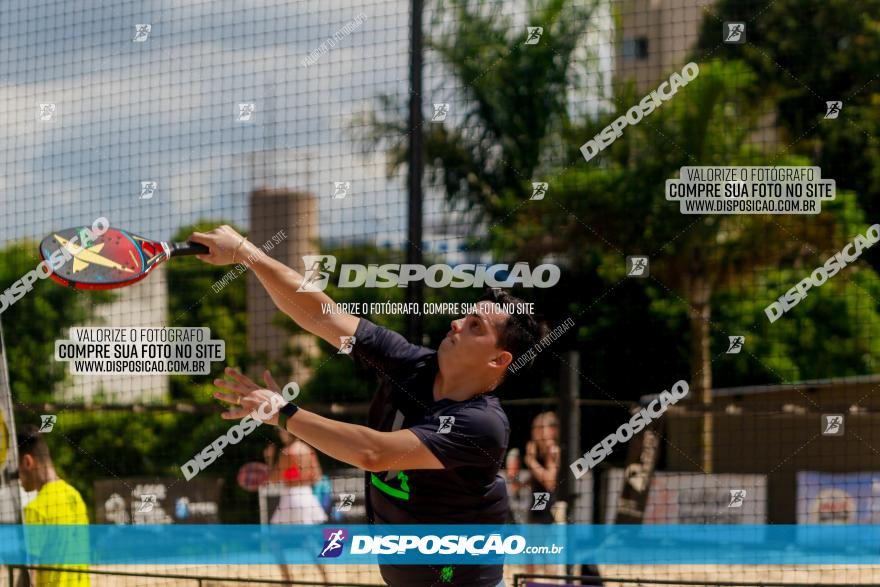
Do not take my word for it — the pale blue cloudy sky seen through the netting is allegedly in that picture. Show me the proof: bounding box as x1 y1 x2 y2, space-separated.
0 0 608 255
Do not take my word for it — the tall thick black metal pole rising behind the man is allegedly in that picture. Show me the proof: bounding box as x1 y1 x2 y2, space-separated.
406 0 425 344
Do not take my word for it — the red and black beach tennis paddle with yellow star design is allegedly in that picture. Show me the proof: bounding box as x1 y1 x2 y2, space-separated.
40 227 209 289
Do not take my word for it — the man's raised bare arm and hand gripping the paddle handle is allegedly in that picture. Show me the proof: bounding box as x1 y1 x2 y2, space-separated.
190 225 360 348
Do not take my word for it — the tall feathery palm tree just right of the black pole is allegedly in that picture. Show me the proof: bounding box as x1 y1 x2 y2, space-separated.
360 0 598 222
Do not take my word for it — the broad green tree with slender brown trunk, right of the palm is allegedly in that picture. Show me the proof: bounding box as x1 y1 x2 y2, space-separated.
496 62 867 471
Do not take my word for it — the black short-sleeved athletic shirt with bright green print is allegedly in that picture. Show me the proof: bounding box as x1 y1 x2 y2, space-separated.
351 318 510 587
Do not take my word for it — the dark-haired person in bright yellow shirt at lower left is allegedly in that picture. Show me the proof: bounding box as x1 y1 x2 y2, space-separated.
16 426 90 587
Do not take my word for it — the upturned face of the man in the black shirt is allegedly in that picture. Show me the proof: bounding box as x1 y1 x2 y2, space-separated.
437 301 513 376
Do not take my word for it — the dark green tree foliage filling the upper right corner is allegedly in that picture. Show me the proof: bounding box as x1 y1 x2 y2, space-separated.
697 0 880 232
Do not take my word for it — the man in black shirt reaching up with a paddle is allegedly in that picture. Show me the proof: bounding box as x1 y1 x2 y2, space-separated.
190 226 541 587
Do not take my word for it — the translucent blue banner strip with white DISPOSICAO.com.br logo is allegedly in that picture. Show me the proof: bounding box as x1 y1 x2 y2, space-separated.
0 525 880 565
